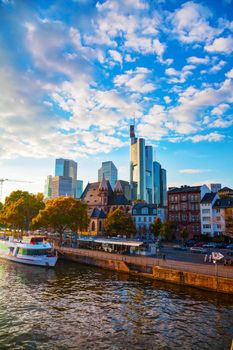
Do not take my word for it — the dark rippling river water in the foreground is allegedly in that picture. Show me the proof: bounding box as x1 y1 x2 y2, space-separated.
0 260 233 350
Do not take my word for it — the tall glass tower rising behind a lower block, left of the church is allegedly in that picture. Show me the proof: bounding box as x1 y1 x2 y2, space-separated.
55 158 77 197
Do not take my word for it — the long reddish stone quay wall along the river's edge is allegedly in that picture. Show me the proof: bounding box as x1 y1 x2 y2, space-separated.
54 246 233 294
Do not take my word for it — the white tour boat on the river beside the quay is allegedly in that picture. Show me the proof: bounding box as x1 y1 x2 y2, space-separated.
0 236 57 267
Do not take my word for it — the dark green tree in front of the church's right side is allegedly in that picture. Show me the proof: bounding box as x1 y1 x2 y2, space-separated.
104 208 136 237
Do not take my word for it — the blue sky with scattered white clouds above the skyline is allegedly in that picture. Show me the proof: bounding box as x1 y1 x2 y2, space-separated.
0 0 233 201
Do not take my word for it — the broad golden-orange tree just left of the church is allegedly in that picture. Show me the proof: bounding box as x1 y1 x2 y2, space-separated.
32 197 89 241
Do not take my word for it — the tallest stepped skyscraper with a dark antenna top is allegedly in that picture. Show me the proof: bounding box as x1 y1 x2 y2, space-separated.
130 125 167 206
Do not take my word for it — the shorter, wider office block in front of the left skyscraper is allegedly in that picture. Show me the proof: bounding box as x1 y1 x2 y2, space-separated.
52 176 74 198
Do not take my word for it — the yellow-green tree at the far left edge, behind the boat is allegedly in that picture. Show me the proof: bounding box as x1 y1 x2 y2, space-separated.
0 191 44 230
